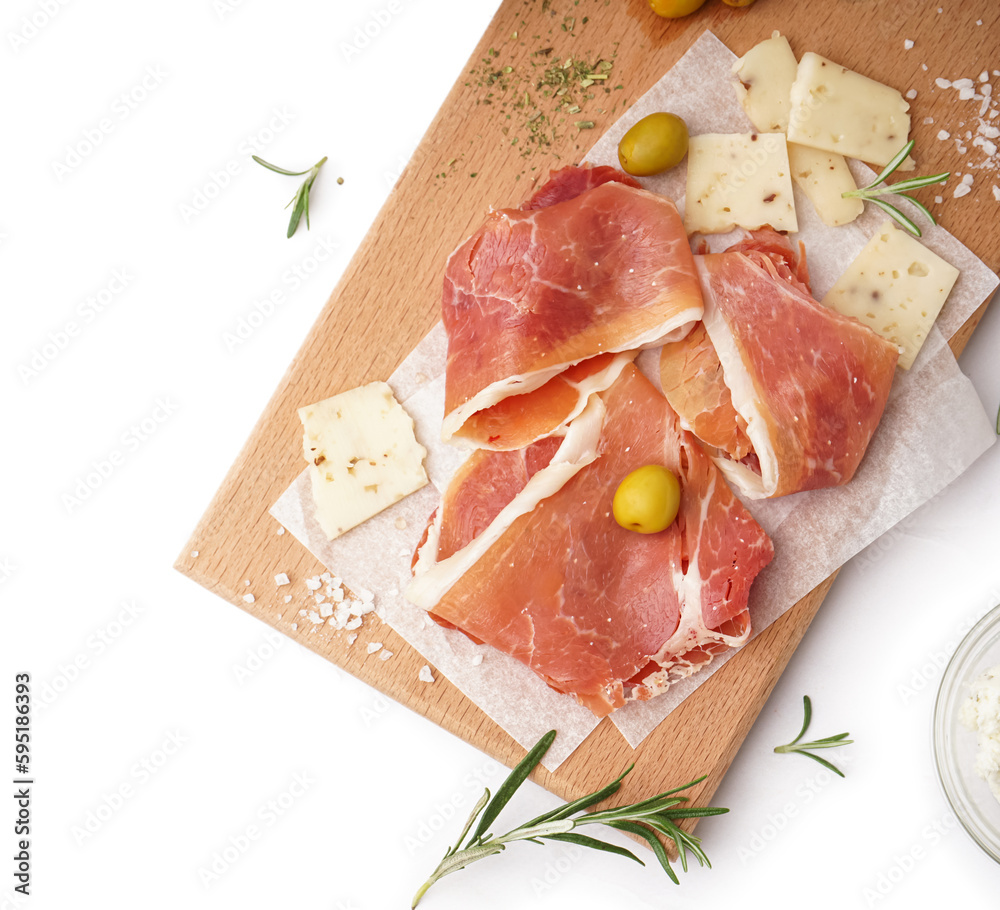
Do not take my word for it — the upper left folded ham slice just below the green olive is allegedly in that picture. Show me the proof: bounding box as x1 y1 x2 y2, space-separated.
442 167 702 449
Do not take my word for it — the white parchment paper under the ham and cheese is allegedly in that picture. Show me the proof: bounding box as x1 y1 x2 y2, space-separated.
271 32 997 770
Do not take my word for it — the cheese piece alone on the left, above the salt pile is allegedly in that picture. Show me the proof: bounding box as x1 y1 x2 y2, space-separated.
299 382 427 540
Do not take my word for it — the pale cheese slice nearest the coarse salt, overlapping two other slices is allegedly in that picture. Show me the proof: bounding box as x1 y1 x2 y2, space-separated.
788 51 912 169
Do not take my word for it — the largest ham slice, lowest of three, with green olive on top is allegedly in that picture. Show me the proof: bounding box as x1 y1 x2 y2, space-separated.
407 364 773 716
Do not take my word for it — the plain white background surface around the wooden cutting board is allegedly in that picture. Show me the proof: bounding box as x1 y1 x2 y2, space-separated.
0 0 1000 910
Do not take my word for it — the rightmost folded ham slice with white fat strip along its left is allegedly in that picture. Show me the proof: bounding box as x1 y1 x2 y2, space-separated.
660 231 899 499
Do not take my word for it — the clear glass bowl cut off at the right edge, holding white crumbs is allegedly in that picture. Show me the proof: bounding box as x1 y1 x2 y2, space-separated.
934 606 1000 863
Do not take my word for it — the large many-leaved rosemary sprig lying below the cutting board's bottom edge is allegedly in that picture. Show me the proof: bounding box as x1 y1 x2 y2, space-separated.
411 730 729 907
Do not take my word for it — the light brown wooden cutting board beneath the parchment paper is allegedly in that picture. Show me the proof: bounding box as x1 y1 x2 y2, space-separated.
176 0 1000 804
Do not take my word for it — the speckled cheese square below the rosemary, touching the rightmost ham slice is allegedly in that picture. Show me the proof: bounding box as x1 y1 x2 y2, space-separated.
823 221 958 370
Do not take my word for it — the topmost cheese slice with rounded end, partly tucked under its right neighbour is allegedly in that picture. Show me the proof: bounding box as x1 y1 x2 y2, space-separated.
733 32 799 133
